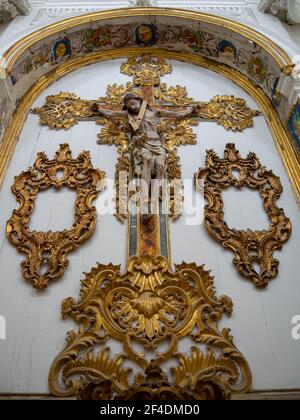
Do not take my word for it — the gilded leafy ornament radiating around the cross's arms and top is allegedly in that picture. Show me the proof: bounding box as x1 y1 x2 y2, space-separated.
33 55 260 222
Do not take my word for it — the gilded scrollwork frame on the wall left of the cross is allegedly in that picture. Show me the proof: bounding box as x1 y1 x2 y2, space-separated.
6 144 105 289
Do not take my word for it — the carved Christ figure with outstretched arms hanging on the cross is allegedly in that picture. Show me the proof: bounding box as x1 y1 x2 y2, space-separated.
92 93 197 208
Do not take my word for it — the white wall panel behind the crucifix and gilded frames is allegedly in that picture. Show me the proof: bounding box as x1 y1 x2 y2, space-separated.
0 60 300 393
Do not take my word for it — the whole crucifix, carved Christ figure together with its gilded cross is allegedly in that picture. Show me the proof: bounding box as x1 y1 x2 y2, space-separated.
33 55 260 259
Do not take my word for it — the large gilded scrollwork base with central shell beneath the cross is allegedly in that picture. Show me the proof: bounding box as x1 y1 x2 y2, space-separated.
49 255 251 400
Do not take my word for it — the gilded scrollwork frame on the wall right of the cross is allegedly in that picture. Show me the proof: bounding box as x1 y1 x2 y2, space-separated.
195 143 292 288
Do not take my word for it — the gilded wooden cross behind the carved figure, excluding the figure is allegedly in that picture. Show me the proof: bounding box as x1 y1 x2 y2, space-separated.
33 55 260 258
